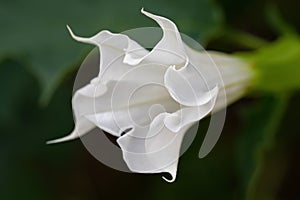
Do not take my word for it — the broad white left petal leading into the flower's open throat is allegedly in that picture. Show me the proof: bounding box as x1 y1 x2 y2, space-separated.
47 64 179 141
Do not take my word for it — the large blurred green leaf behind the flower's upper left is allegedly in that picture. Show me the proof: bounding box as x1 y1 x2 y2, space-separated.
0 0 222 103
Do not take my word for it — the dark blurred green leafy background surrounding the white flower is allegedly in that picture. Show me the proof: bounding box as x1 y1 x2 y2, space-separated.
0 0 300 200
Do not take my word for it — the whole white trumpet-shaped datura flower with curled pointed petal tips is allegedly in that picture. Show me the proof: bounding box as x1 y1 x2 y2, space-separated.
48 9 253 182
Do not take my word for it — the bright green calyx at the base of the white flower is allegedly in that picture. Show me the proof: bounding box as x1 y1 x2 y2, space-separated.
236 35 300 93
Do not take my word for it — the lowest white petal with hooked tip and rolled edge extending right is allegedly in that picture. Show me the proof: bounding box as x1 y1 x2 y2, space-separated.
117 89 217 182
